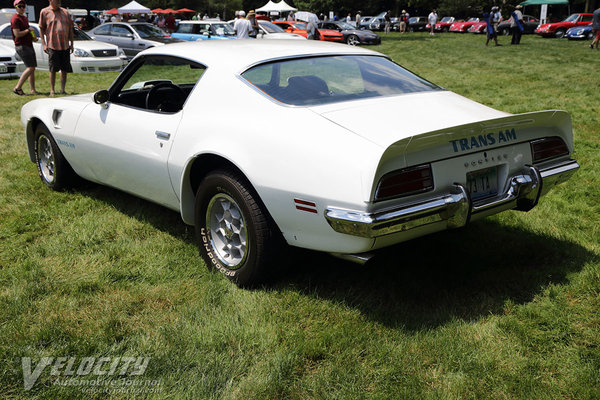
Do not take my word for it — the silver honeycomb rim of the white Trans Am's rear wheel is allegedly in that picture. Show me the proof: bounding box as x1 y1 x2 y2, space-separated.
206 193 248 269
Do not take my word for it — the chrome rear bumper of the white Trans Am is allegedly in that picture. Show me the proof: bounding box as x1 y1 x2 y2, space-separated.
325 160 579 238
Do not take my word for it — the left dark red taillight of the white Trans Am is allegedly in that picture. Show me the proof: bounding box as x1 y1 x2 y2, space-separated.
375 164 433 201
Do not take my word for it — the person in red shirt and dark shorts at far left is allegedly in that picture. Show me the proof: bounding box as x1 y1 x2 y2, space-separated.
10 0 38 96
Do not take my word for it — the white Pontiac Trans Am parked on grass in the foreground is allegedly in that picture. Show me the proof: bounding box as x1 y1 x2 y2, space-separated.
21 40 579 286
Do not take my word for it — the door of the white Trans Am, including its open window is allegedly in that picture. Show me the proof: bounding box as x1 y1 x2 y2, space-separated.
73 55 204 209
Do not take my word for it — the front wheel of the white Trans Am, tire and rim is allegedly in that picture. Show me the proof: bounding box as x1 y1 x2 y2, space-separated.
34 124 77 191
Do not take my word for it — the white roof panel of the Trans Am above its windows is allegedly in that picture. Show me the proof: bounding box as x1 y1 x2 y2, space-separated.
141 39 387 73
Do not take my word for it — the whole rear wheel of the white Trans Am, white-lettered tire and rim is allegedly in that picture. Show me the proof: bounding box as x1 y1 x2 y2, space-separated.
195 169 282 287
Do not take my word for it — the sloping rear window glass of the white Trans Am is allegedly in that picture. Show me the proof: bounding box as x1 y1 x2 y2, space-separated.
242 56 442 106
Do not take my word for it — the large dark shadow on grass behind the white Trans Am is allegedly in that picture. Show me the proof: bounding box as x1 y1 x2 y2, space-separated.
276 221 597 331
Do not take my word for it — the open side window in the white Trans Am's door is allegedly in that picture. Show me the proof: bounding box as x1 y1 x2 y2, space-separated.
111 56 206 113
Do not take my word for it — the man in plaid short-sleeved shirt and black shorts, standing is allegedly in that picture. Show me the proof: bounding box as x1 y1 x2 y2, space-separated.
40 0 73 96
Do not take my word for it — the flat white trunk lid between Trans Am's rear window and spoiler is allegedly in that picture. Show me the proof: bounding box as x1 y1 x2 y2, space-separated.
312 91 510 147
